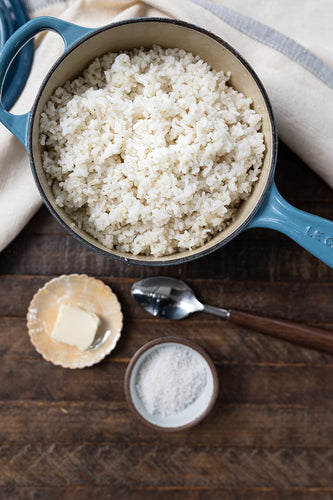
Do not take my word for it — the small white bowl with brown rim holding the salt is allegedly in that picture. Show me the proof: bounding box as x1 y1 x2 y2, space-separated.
124 337 219 431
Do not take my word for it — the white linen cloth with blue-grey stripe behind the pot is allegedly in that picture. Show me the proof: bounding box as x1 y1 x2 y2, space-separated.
0 0 333 251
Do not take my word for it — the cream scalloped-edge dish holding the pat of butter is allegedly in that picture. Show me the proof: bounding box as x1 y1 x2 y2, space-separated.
27 274 123 369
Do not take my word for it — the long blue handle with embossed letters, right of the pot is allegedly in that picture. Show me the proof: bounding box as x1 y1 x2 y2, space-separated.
246 183 333 268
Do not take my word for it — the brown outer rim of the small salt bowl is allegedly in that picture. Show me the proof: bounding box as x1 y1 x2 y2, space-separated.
124 337 219 432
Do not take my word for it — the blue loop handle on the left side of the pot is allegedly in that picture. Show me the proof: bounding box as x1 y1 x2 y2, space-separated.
0 17 94 149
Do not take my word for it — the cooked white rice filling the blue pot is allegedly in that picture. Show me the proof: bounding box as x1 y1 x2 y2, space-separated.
40 46 265 257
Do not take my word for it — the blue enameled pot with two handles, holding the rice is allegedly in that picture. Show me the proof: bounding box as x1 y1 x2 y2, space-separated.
0 17 333 267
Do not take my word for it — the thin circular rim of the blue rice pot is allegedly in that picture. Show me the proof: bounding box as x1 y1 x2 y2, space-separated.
28 17 278 266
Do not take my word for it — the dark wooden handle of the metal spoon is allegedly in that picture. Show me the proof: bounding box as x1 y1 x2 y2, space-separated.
229 309 333 354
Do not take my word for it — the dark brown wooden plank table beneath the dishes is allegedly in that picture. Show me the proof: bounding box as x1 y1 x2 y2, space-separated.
0 145 333 500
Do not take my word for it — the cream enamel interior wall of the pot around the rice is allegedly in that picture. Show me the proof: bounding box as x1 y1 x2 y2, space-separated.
31 20 275 264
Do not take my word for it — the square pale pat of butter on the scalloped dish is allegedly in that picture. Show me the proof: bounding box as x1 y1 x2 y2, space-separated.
51 304 101 351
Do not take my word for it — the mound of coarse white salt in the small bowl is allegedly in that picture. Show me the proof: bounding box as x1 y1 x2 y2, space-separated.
136 344 207 416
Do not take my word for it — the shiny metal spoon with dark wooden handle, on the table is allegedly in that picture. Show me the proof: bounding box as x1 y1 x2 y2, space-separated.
131 276 333 354
